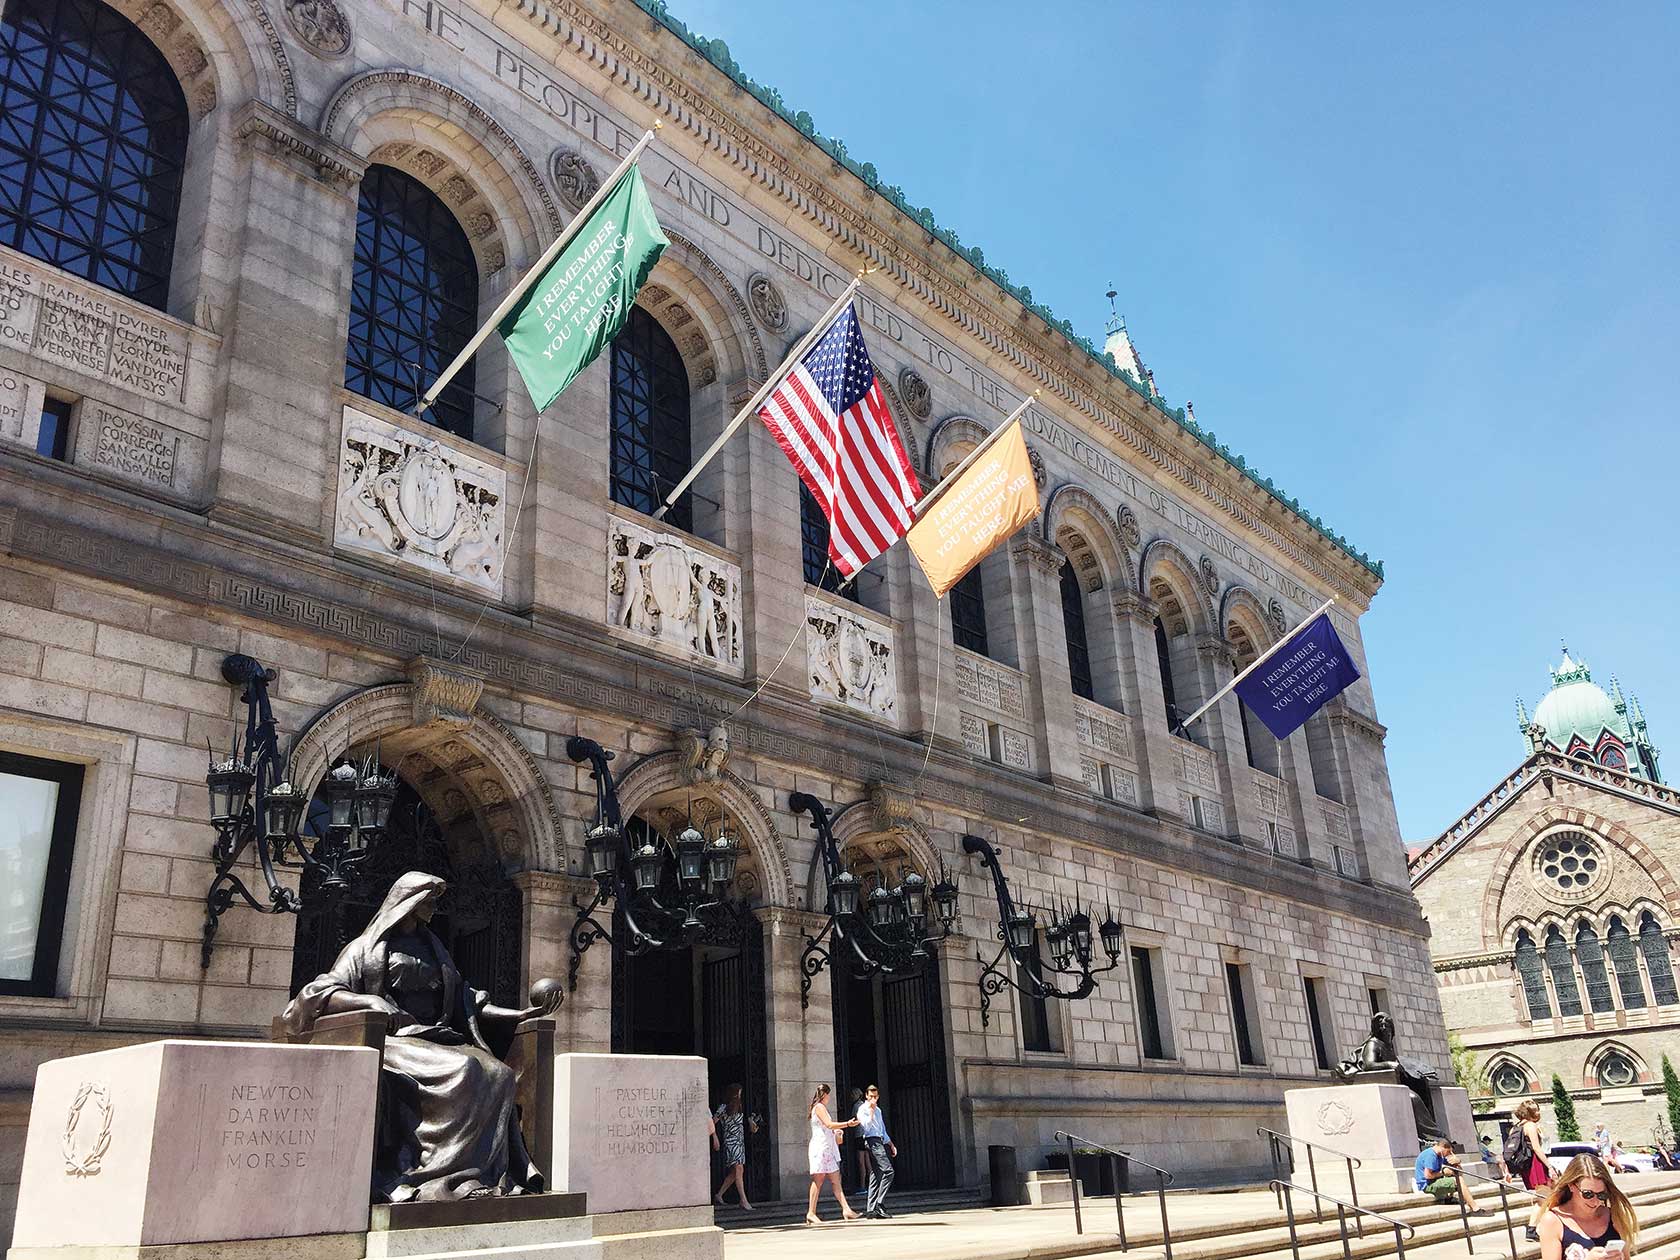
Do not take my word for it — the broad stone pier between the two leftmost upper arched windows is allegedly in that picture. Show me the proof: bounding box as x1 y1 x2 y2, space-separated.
210 106 366 537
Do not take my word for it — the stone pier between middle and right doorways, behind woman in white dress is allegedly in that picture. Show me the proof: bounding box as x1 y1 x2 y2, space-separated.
763 906 835 1200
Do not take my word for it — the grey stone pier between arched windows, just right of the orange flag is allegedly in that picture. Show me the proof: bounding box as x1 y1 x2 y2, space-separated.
1010 533 1085 793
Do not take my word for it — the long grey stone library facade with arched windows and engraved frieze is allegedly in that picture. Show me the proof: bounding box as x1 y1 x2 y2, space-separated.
0 0 1446 1236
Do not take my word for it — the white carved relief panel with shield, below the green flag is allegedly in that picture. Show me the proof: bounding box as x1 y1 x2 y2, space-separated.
333 407 507 596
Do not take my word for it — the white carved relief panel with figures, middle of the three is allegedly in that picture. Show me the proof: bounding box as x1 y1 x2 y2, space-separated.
606 516 744 675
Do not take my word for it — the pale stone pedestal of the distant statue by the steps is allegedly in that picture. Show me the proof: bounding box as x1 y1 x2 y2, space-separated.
1284 1085 1488 1198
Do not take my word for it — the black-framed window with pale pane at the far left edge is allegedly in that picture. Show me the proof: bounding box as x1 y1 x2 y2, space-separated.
0 753 82 996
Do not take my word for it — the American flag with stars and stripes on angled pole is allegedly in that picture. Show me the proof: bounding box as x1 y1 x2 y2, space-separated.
758 306 922 578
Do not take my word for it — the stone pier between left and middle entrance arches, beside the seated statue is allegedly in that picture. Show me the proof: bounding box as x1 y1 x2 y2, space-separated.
514 870 613 1053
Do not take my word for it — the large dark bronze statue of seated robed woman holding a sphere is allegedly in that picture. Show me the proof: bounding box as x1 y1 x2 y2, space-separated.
282 870 558 1203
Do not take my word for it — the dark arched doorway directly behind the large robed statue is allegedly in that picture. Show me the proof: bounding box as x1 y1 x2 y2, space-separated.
292 781 526 1014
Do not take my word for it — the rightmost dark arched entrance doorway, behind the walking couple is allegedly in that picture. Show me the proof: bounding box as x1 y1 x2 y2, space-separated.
830 959 956 1191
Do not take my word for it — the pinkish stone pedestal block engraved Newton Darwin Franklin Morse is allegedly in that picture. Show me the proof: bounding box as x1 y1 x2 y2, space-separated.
10 1042 380 1258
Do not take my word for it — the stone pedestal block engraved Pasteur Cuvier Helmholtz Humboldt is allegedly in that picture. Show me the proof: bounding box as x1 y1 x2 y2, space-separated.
548 1053 711 1215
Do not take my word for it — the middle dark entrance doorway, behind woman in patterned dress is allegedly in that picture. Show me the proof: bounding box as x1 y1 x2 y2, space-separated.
613 887 773 1201
